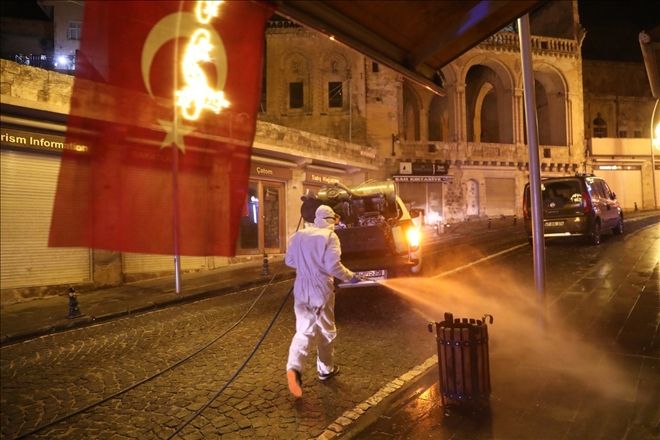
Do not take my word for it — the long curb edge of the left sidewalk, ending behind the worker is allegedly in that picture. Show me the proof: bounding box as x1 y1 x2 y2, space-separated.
0 270 295 347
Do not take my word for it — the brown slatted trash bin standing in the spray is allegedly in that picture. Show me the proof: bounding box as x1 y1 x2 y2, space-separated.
428 313 493 408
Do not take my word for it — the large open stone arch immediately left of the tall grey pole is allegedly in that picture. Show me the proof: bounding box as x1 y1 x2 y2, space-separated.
463 56 513 144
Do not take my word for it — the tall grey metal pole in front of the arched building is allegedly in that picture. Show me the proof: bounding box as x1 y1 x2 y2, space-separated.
518 15 545 304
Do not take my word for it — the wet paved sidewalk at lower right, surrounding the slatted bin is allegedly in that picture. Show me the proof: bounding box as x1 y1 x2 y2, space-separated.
354 215 660 440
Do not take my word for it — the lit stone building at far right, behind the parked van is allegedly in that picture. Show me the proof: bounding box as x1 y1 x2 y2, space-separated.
583 60 660 210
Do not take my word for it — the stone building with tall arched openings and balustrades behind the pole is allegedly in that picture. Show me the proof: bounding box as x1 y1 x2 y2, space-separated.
388 2 585 221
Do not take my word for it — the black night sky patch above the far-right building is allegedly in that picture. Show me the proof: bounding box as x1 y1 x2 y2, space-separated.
578 0 660 63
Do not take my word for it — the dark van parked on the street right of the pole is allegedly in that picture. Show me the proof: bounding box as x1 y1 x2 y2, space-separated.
523 174 623 245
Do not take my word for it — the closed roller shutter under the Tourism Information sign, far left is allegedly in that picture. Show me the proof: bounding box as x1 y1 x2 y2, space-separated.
0 151 91 289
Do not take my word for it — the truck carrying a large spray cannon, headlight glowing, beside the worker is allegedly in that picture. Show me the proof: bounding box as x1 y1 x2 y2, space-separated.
300 180 422 286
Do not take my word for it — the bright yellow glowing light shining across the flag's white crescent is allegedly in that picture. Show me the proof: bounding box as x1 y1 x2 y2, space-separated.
176 1 229 121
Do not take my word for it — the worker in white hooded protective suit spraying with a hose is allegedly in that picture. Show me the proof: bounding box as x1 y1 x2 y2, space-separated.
285 205 360 397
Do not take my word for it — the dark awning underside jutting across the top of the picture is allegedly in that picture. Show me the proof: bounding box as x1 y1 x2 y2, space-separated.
276 0 546 94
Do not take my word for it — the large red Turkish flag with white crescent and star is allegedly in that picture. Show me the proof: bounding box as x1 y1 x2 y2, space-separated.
49 1 273 256
